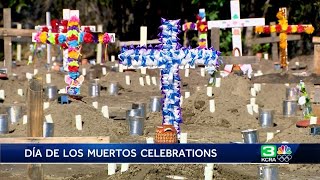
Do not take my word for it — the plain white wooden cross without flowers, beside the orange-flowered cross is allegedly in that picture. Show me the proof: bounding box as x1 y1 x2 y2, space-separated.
208 0 265 54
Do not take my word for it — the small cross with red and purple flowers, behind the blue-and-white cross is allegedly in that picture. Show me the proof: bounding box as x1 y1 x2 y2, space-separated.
182 9 208 48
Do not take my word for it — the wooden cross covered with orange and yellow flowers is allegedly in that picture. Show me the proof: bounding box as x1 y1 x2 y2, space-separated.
255 8 314 68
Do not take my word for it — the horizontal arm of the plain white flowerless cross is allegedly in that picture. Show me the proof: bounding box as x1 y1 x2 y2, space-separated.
208 18 265 29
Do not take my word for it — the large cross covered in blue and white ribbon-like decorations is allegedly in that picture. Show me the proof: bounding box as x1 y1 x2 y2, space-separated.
119 19 220 137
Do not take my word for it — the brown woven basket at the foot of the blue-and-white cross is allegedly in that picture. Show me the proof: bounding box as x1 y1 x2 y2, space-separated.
155 125 178 144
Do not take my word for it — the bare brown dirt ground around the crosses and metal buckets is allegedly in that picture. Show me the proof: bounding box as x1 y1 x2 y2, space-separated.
0 53 320 180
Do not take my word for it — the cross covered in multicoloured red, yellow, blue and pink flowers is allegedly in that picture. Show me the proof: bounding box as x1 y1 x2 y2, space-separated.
33 10 114 96
